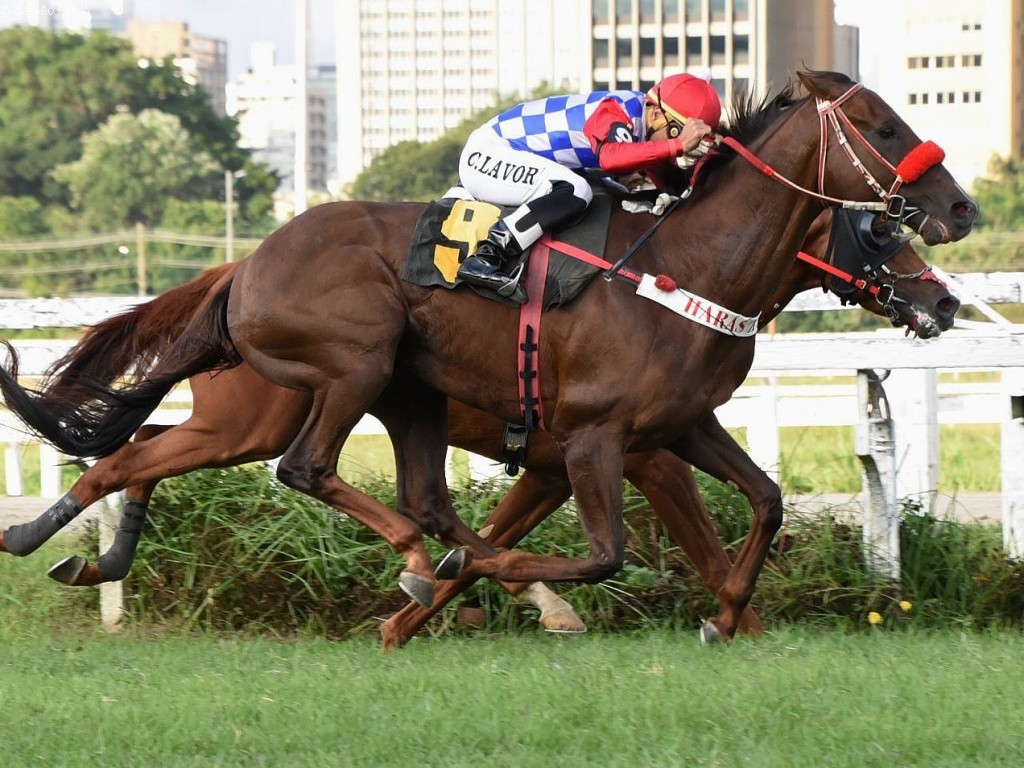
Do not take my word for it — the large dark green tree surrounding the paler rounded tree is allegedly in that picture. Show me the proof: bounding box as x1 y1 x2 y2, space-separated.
0 27 276 219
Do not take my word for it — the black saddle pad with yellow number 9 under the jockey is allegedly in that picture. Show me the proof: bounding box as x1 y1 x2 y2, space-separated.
401 193 613 309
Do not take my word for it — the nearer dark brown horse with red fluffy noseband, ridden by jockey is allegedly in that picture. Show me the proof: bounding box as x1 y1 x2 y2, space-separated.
0 73 977 639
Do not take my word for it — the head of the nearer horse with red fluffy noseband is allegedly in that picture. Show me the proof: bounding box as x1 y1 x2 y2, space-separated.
799 72 978 245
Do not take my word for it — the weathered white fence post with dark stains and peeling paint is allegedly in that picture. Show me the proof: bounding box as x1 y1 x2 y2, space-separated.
854 370 900 580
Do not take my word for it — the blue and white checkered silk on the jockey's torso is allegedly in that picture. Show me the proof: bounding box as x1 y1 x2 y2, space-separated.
488 91 644 168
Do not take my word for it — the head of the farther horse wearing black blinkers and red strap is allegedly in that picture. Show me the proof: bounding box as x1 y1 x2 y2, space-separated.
790 209 959 339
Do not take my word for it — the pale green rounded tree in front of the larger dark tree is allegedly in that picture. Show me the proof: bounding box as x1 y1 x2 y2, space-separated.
52 110 219 229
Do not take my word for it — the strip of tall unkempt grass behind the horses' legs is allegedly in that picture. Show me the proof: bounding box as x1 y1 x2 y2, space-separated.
46 466 1007 638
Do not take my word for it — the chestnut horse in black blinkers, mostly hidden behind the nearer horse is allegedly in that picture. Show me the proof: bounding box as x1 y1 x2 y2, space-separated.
0 211 958 647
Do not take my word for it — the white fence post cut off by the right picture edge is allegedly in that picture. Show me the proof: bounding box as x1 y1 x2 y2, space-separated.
999 368 1024 558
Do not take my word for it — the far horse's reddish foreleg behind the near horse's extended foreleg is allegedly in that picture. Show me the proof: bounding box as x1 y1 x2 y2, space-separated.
626 451 764 635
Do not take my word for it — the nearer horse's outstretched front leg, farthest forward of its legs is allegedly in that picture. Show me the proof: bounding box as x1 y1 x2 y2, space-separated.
672 414 782 641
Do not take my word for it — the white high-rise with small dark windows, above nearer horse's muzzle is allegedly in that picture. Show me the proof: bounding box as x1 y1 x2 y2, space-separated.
850 0 1024 188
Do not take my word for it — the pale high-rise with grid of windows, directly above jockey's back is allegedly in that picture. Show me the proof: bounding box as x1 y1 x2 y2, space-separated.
336 0 587 191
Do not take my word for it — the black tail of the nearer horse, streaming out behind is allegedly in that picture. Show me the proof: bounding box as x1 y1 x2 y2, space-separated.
0 280 241 457
